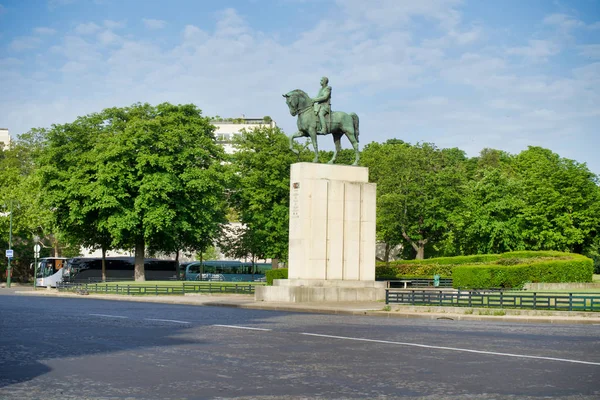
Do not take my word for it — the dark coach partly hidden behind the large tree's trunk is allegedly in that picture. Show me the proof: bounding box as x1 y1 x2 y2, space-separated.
63 257 178 283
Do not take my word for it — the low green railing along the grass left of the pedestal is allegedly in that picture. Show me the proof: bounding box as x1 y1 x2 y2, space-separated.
56 282 254 296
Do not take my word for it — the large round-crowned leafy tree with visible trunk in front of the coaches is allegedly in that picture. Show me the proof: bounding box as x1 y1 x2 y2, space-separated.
39 103 225 280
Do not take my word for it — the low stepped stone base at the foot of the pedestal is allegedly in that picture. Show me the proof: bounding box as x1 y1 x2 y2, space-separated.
254 279 386 303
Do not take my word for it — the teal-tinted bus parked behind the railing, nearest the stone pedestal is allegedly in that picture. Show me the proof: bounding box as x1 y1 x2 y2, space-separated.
180 260 271 282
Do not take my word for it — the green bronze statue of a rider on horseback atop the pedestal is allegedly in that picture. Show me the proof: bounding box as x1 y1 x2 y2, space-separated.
283 77 360 165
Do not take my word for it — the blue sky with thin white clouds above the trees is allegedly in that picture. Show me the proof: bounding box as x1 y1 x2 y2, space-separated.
0 0 600 174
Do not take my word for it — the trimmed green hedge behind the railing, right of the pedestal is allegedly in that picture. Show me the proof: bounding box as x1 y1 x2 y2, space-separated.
375 251 593 288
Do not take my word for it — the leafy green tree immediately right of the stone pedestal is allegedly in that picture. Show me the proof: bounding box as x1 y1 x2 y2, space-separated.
362 140 465 259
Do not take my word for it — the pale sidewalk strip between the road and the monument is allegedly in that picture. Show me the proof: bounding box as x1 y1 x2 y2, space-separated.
8 287 600 325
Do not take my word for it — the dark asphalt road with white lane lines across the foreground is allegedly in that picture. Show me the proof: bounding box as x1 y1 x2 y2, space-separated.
0 292 600 399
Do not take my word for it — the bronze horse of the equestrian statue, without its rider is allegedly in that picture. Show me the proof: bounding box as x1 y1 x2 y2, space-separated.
283 89 360 165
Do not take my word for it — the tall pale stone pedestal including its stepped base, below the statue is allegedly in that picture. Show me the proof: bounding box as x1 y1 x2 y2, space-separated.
255 163 385 302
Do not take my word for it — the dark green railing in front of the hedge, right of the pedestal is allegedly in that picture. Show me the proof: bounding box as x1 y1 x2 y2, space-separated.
385 289 600 311
